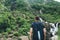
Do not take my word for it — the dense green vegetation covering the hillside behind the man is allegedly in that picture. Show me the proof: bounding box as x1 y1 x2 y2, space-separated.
0 0 60 36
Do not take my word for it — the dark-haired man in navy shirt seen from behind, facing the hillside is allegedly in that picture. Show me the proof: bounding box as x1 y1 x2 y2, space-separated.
30 17 46 40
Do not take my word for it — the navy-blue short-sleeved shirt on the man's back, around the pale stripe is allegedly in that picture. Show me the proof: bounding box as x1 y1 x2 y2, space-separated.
31 22 44 40
